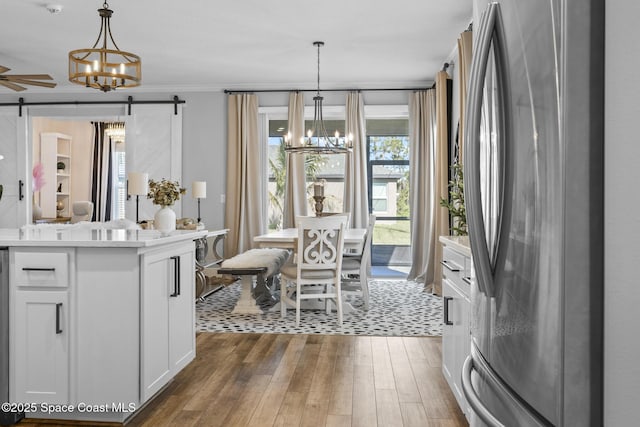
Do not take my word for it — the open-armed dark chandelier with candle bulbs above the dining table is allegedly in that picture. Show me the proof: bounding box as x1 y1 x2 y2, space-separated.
284 42 353 154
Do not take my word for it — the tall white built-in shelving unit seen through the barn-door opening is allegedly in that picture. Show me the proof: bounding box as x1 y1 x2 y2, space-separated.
40 132 72 218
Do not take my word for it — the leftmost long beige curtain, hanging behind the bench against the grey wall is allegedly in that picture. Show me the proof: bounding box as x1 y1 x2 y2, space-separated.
224 94 266 258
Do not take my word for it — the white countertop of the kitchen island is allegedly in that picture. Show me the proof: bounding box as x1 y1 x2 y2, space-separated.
0 226 208 248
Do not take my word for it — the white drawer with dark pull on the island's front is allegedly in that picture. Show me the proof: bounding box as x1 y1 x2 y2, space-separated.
13 252 69 287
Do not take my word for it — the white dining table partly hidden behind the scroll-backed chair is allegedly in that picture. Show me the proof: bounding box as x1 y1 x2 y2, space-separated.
253 228 367 314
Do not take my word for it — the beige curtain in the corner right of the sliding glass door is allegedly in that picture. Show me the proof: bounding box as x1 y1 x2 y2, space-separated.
408 77 449 293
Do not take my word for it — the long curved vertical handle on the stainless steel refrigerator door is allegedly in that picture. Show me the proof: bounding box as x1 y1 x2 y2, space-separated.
464 3 504 297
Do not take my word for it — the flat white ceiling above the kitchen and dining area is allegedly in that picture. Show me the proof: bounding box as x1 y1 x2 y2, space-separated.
0 0 472 95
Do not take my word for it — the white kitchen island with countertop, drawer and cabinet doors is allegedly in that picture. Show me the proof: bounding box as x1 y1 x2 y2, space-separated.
0 227 207 422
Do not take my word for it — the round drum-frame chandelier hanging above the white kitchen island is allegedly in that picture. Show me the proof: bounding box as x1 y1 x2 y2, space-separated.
69 2 142 92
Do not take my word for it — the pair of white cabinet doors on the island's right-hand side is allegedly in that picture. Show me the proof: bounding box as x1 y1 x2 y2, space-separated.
141 242 195 402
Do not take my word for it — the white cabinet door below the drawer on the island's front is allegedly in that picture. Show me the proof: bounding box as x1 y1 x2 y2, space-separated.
11 290 70 404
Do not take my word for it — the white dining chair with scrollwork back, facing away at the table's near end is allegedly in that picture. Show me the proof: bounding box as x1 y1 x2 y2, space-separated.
280 216 346 326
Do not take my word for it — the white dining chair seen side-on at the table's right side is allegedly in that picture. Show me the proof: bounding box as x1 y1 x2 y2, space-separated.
342 214 376 310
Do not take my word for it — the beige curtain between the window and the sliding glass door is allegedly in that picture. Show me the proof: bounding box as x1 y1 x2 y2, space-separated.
343 92 369 228
